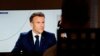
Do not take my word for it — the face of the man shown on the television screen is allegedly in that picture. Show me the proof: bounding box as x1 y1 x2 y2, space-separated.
31 16 45 34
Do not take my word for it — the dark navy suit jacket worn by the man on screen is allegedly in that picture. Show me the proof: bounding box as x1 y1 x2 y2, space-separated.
11 30 56 56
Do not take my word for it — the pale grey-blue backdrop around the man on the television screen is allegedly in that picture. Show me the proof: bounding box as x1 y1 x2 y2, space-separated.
0 9 61 52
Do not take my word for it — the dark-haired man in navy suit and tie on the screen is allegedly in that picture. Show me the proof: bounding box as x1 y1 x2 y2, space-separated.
11 12 56 56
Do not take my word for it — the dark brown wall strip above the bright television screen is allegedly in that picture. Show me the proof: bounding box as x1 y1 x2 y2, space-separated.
0 0 62 10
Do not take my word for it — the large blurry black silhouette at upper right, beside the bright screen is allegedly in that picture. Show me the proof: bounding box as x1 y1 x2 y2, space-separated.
62 0 90 28
